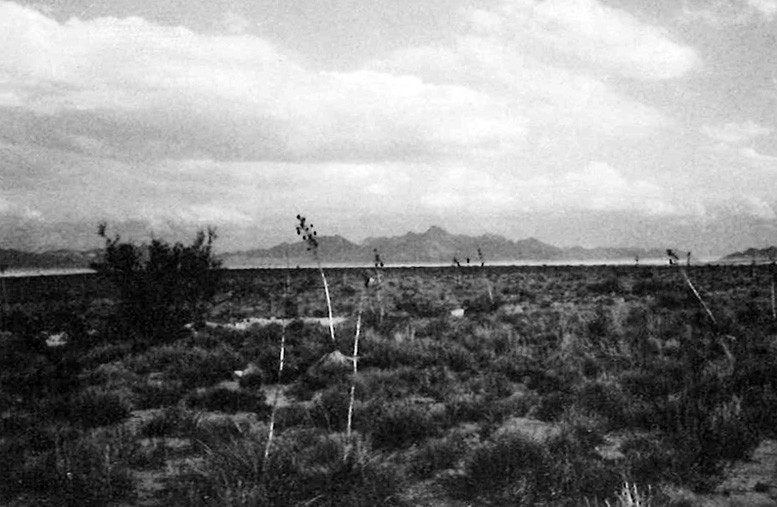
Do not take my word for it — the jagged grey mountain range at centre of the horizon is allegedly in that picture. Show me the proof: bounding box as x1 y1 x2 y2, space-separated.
220 226 666 267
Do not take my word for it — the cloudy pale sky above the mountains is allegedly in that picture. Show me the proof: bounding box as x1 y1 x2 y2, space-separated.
0 0 777 255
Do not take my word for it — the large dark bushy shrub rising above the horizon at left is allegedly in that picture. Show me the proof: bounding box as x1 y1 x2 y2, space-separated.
92 224 220 341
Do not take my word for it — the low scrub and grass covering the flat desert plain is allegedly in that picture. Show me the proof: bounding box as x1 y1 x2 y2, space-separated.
0 260 777 506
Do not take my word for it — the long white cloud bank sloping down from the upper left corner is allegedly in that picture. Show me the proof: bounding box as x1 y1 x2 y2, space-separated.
0 2 525 160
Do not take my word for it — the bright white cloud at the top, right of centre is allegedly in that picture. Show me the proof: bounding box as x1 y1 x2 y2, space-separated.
371 0 672 145
